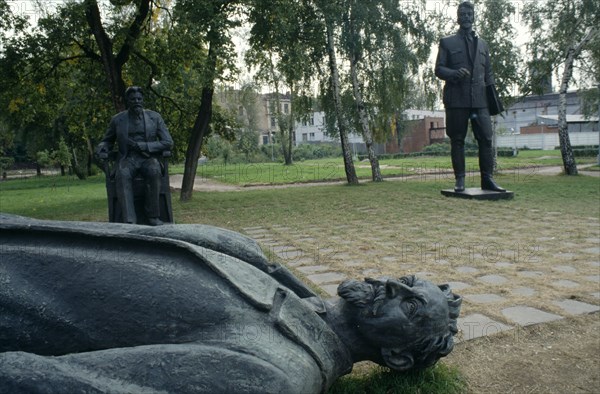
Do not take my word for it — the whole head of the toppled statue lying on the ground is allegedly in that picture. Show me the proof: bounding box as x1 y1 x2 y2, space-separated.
338 276 462 371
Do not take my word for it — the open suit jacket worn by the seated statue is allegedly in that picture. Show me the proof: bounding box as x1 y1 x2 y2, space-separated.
101 109 173 157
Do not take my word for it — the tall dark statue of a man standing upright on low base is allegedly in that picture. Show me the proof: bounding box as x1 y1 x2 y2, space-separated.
435 1 506 192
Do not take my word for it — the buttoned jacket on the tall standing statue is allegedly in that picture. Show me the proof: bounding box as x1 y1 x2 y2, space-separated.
435 33 494 108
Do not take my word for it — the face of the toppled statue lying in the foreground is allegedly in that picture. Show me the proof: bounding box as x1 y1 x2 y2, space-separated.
359 276 449 348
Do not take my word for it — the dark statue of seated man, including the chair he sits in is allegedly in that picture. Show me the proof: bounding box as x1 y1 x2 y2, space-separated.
96 86 173 226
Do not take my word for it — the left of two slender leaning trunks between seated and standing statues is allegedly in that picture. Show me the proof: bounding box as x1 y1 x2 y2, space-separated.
325 21 358 185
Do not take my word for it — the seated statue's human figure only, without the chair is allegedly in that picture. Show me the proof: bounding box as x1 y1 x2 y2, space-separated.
97 86 173 226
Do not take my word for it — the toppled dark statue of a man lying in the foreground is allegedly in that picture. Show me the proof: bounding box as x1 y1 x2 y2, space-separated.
0 215 461 394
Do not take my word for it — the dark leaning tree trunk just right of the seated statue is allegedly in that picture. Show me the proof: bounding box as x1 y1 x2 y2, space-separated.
179 32 218 201
